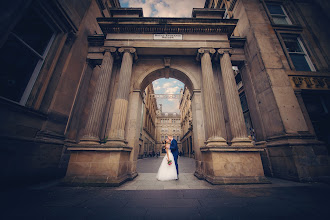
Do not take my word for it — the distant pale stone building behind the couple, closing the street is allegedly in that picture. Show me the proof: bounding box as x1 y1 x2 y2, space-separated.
156 111 182 153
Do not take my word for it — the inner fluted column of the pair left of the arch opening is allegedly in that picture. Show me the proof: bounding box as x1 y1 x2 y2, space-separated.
107 48 136 146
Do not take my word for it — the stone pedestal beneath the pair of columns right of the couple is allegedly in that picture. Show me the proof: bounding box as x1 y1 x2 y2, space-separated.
199 147 270 184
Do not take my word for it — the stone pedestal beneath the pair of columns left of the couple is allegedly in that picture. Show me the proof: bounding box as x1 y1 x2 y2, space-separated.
62 145 133 186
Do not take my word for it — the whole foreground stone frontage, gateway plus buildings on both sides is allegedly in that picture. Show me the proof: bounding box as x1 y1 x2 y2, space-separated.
0 0 330 186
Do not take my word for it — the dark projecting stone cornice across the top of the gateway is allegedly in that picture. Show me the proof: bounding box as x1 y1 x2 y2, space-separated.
97 17 238 36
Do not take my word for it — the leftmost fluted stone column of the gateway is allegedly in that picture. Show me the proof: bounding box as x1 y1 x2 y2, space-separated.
80 48 116 144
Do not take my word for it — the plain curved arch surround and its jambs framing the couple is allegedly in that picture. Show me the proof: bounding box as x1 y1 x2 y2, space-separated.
126 63 205 179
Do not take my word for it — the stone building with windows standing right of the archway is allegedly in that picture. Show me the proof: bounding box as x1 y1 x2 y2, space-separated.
205 0 330 181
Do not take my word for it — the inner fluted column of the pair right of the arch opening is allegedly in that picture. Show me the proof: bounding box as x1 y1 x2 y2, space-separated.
198 49 227 146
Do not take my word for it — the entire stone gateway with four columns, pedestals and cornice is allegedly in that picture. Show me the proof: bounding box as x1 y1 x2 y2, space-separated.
66 9 265 185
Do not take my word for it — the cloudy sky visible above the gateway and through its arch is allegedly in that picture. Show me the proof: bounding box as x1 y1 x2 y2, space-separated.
119 0 201 113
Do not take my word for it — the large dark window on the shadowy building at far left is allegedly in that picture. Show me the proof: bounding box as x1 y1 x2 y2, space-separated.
0 8 55 105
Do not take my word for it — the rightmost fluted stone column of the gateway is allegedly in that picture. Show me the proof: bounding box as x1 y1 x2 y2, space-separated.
218 49 252 146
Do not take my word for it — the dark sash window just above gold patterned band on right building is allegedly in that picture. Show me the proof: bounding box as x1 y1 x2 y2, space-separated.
282 34 315 71
